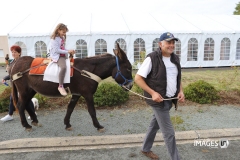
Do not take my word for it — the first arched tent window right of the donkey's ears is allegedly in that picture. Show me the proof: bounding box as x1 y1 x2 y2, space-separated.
134 38 146 62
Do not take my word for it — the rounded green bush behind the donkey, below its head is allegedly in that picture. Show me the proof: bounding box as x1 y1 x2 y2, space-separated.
94 83 129 106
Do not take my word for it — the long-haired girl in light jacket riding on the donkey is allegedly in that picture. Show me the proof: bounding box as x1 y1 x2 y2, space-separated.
50 23 75 96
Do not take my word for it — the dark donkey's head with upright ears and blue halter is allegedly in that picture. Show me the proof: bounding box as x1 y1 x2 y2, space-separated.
112 43 133 89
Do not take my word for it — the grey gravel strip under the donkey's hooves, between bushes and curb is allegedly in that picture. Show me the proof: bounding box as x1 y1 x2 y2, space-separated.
0 105 240 141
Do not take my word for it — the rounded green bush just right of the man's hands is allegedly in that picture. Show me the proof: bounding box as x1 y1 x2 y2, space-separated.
184 80 219 104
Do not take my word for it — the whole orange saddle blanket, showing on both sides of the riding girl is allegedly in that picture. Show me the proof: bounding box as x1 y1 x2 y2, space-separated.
29 58 74 77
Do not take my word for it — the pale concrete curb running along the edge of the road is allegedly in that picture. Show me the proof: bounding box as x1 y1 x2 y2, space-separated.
0 128 240 151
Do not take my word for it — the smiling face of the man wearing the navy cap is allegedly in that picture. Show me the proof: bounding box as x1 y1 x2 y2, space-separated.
158 40 175 56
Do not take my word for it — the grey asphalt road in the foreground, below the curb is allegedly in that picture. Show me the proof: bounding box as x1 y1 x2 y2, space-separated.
0 140 240 160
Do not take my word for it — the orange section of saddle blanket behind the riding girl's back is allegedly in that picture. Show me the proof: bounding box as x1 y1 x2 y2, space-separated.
29 58 47 75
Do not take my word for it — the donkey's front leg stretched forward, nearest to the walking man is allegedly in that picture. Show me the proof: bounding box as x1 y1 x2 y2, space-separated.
84 95 104 131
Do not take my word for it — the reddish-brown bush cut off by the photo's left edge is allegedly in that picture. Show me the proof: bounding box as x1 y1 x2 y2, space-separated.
0 87 12 112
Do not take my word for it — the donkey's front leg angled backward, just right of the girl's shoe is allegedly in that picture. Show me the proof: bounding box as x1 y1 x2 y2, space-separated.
64 95 80 130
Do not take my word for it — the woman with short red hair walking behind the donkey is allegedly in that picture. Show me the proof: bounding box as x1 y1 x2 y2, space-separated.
1 45 35 122
